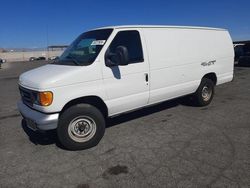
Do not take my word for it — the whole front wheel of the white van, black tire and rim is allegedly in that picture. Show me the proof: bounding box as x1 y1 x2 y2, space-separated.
57 104 105 150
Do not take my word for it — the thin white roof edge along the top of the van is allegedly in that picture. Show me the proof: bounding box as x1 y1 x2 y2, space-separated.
94 25 226 31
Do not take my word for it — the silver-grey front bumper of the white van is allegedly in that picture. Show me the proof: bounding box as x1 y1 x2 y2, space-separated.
17 101 59 130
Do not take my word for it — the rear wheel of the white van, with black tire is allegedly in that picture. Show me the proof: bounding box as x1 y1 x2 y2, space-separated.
192 78 214 106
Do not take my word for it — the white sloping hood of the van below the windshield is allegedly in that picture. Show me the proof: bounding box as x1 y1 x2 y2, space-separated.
19 64 101 90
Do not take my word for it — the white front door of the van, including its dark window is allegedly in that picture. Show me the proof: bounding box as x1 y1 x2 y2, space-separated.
103 29 149 115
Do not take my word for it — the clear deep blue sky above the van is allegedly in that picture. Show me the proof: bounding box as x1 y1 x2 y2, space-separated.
0 0 250 48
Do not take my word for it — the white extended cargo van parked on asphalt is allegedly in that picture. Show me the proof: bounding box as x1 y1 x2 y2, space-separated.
18 26 234 150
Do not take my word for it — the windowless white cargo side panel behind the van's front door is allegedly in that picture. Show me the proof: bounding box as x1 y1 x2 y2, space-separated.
144 28 233 103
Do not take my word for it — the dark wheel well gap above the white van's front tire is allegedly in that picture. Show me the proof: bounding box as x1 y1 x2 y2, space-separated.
61 96 108 118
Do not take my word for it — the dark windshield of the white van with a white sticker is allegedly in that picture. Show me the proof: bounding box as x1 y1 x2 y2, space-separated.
53 29 113 66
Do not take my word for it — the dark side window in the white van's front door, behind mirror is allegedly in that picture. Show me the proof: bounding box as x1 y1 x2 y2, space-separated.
109 31 144 63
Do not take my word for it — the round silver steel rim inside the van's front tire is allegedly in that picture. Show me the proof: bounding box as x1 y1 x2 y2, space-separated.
68 116 96 142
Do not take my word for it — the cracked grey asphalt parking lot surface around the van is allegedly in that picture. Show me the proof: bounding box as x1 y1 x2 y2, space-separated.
0 62 250 188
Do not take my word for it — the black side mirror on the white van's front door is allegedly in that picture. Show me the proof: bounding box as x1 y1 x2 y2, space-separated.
105 46 128 67
